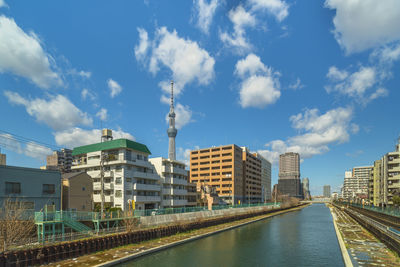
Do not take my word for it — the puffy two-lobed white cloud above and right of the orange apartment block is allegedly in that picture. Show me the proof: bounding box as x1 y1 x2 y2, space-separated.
235 54 281 108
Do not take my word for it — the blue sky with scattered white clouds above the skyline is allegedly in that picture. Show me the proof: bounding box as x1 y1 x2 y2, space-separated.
0 0 400 195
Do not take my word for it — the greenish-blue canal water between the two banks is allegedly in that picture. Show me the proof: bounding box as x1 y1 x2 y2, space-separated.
120 204 344 267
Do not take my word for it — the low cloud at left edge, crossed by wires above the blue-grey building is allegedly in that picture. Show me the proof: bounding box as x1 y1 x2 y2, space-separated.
0 133 53 161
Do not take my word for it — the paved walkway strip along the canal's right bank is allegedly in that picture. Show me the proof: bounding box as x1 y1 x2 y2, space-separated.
331 206 400 267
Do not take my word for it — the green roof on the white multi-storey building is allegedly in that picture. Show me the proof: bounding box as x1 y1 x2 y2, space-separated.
72 139 151 156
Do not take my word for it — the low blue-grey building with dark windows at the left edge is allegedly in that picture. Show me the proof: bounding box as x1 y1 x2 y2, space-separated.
0 165 61 211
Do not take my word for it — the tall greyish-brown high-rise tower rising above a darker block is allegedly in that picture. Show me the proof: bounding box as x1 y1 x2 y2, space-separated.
279 152 300 179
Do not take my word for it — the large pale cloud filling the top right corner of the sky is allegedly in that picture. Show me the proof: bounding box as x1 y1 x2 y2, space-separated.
325 0 400 54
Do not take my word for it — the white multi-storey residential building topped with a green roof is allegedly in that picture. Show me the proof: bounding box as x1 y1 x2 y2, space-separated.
72 129 161 213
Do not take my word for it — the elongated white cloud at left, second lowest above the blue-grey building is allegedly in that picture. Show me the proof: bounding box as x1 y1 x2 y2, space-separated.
4 91 92 130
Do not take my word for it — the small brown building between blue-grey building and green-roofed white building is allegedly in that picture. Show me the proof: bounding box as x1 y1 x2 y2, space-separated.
61 172 93 211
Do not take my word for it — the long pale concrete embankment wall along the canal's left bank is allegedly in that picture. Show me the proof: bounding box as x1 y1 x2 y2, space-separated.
140 205 276 227
